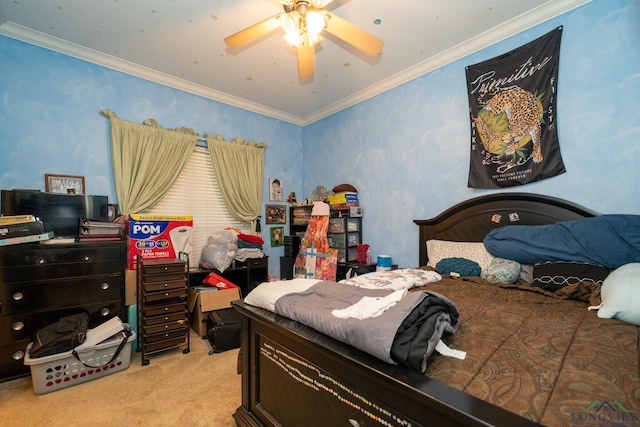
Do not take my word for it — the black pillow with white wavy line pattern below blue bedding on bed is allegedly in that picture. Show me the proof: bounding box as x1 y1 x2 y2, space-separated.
532 261 609 292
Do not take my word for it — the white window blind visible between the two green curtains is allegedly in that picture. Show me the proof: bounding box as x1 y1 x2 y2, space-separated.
144 146 251 267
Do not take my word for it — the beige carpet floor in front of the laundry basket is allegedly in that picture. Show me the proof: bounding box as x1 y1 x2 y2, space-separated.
0 331 242 427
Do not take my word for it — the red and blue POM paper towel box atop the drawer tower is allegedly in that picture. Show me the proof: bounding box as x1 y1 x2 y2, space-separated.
128 214 193 270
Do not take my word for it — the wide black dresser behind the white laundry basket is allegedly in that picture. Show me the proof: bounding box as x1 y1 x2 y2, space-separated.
0 241 127 381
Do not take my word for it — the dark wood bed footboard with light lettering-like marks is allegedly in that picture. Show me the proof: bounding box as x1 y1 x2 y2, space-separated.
233 301 538 427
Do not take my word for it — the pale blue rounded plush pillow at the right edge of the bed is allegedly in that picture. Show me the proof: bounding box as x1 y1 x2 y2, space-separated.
598 262 640 326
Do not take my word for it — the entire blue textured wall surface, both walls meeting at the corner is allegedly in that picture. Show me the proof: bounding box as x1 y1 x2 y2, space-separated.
0 0 640 276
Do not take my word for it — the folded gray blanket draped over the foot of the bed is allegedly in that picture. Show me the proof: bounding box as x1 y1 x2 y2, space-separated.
275 281 459 372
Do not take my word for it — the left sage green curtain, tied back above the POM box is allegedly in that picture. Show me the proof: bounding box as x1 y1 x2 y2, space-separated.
100 110 198 214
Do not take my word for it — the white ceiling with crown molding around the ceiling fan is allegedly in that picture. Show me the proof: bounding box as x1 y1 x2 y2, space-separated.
0 0 590 125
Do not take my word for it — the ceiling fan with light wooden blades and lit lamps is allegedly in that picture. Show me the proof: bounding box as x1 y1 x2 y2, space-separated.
224 0 383 78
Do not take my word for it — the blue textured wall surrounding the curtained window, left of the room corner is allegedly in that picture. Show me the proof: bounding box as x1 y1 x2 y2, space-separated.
0 36 303 275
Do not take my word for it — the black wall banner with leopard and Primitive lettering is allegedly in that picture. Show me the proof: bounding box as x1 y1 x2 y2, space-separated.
466 27 566 188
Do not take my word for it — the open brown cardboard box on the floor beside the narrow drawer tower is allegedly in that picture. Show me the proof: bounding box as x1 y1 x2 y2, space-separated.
187 286 240 337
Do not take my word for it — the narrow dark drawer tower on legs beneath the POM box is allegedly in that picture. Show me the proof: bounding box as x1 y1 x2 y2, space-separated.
137 258 190 365
